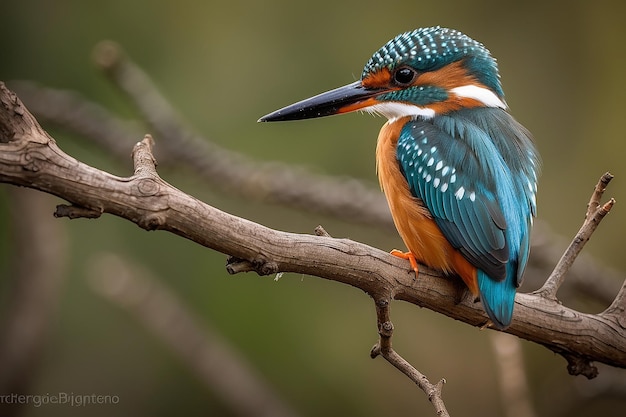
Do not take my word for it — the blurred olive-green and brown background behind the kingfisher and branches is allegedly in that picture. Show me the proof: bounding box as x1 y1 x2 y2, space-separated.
0 0 626 417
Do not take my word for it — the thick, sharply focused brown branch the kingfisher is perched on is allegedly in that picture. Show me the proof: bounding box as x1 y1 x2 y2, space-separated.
0 84 626 377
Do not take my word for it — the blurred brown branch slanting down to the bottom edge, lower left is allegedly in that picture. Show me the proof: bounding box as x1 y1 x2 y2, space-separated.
90 250 297 417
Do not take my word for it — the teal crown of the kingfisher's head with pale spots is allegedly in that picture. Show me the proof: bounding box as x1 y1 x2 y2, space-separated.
361 26 504 98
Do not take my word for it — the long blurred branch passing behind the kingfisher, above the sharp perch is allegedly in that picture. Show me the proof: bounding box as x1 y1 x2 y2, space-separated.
13 82 625 305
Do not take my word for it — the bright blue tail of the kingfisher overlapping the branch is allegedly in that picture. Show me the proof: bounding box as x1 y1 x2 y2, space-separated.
477 262 517 330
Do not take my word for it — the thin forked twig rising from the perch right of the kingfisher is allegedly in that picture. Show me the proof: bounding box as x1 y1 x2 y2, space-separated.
535 172 615 301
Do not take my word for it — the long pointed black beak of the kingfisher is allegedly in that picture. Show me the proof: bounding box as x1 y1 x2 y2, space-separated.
259 81 384 122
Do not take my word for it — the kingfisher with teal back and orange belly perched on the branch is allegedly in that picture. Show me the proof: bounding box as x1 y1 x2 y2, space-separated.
259 26 540 330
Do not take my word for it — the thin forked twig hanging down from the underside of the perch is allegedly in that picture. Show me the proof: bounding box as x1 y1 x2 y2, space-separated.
370 298 450 417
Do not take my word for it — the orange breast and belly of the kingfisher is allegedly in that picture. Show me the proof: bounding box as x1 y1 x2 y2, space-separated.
376 118 478 295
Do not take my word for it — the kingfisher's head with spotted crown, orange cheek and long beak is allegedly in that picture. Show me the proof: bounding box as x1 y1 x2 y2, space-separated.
259 26 506 122
